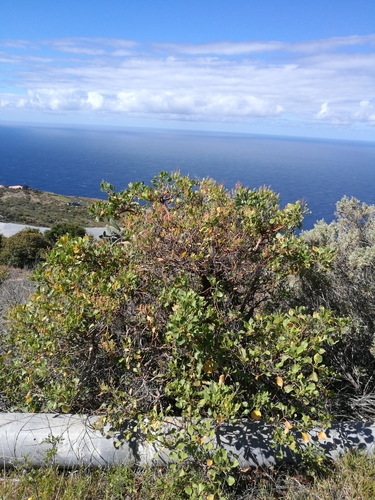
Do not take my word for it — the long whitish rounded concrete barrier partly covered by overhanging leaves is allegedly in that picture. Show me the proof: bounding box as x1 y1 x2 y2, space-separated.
0 413 375 468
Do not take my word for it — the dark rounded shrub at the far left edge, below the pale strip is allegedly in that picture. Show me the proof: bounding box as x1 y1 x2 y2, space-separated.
0 228 50 268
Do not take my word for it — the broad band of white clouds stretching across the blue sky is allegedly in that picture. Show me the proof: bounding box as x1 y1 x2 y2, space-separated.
0 35 375 127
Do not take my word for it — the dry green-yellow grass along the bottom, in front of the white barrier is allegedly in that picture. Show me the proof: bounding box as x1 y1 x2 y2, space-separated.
0 454 375 500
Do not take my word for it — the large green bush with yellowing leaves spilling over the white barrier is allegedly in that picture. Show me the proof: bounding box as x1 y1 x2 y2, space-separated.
2 172 344 498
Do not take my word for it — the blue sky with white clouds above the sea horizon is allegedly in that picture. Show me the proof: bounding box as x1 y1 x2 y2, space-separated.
0 0 375 141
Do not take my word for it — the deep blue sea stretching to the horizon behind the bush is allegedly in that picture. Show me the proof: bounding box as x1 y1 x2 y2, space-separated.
0 125 375 229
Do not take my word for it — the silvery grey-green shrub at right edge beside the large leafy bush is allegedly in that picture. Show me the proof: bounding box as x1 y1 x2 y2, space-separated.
301 197 375 419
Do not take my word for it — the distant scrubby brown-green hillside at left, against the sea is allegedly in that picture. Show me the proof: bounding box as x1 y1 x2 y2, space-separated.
0 186 101 227
